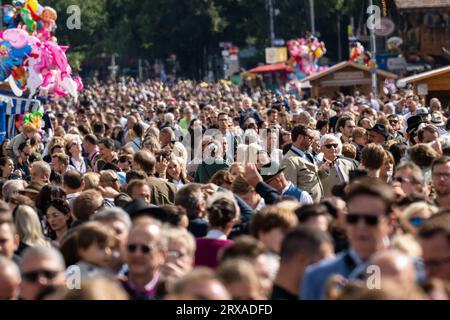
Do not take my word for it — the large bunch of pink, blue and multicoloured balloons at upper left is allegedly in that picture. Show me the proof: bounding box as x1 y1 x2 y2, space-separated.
0 0 83 100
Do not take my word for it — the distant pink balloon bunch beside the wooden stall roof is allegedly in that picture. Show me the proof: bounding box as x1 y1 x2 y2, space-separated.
287 34 327 78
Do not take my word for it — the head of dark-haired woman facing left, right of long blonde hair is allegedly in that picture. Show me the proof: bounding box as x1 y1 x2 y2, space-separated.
45 200 72 246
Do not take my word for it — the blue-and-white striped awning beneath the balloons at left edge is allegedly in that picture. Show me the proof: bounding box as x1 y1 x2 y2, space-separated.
0 95 43 139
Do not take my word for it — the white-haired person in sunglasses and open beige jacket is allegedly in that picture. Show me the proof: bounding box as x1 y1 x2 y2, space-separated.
319 134 356 197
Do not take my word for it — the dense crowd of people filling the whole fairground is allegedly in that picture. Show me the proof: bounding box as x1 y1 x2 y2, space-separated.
0 78 450 300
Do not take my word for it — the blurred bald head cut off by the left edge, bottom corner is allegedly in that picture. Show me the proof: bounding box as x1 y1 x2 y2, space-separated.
0 256 20 300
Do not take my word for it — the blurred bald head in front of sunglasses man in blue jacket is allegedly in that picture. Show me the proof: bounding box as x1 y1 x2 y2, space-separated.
369 250 416 286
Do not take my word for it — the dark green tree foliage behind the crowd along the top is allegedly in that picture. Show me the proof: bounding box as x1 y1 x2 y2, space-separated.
40 0 362 78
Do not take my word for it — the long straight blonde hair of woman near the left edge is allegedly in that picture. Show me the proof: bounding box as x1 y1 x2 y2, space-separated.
13 204 50 255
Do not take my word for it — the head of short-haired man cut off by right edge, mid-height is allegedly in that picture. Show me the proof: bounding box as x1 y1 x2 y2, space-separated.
431 156 450 208
